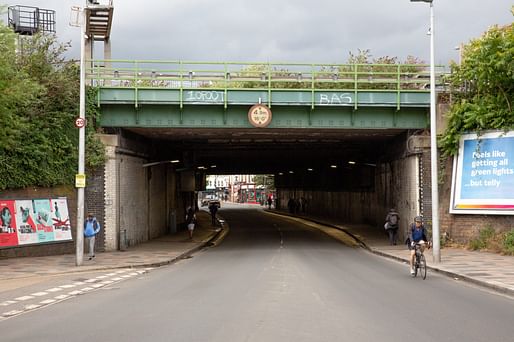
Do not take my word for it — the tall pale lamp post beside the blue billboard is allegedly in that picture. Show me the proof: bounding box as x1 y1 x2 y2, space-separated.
410 0 441 263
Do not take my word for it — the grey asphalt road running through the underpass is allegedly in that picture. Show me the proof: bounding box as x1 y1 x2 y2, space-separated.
0 208 514 342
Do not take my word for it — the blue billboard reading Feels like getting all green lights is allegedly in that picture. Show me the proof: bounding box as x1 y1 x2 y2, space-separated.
450 131 514 215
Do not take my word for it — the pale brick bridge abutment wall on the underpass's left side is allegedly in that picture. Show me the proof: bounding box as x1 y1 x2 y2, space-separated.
86 134 186 251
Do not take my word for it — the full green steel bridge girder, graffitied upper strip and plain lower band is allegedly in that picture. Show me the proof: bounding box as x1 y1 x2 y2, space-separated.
98 88 430 129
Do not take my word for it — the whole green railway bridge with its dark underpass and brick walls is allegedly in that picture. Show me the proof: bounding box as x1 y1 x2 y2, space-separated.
89 63 436 249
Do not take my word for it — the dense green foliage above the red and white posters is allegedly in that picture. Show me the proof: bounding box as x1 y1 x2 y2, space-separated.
0 24 103 190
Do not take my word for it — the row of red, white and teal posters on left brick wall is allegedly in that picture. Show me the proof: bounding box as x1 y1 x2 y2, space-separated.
0 197 73 248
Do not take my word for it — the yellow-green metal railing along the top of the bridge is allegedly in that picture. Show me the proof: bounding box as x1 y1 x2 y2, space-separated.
90 60 445 107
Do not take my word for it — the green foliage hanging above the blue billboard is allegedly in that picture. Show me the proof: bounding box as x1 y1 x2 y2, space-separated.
440 19 514 155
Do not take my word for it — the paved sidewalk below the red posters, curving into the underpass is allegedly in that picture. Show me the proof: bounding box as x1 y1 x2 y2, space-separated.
0 211 228 289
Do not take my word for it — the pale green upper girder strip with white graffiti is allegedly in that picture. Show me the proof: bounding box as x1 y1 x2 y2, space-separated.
98 88 430 109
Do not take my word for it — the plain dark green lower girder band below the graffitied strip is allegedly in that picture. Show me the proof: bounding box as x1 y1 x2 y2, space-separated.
101 104 429 129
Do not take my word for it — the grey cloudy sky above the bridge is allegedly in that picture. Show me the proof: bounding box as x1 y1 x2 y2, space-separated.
4 0 514 64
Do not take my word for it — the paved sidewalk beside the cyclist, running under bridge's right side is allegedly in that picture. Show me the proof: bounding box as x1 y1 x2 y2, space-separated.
273 211 514 296
